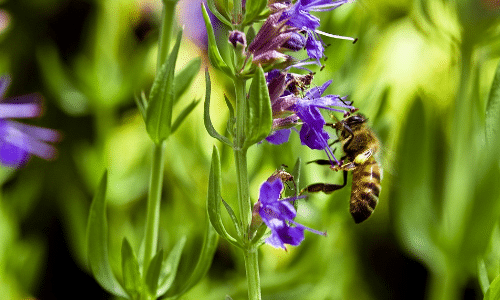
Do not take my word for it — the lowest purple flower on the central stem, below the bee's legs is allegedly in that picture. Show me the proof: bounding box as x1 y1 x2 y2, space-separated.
256 178 326 250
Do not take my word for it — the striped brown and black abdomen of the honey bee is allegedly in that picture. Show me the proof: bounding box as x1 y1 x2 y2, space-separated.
350 157 381 223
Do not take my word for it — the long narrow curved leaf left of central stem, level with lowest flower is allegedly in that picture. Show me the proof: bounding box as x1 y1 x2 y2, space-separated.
207 146 238 246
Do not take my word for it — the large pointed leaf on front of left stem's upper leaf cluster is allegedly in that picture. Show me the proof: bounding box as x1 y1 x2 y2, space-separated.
146 31 182 144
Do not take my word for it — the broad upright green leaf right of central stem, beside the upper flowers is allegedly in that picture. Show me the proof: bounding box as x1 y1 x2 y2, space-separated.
243 66 273 148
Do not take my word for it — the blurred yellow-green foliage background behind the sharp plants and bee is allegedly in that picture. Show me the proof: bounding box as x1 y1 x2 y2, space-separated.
0 0 500 300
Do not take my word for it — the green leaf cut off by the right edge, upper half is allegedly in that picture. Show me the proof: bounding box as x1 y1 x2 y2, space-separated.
486 63 500 143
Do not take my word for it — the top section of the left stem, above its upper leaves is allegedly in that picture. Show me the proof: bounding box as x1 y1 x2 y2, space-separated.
156 1 177 72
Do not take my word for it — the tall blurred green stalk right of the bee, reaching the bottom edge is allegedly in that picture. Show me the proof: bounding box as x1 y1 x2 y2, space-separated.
431 36 477 300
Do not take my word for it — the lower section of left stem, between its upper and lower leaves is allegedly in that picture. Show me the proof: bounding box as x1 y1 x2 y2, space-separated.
143 141 166 282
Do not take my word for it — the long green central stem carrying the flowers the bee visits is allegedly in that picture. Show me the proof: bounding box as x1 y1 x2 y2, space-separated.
234 77 261 300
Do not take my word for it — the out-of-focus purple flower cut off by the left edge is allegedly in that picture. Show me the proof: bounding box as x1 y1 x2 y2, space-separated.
0 76 60 167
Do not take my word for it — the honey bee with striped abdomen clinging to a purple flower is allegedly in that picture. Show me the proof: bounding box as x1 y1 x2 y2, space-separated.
302 114 382 223
